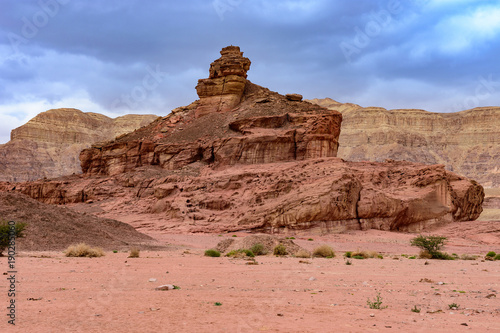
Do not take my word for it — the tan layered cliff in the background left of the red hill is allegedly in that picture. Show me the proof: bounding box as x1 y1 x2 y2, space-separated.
0 109 157 182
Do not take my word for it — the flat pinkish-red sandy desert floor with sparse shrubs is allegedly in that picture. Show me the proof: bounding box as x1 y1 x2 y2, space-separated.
0 222 500 333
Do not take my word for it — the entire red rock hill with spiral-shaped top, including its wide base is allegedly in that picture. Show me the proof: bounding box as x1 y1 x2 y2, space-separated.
0 46 484 233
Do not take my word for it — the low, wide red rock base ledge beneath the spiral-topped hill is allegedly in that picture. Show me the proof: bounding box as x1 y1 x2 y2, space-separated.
0 158 484 234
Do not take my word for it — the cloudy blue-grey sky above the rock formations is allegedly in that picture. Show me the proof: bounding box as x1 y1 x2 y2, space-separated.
0 0 500 143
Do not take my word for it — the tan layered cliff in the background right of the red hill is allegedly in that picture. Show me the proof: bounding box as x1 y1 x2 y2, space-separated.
311 98 500 187
